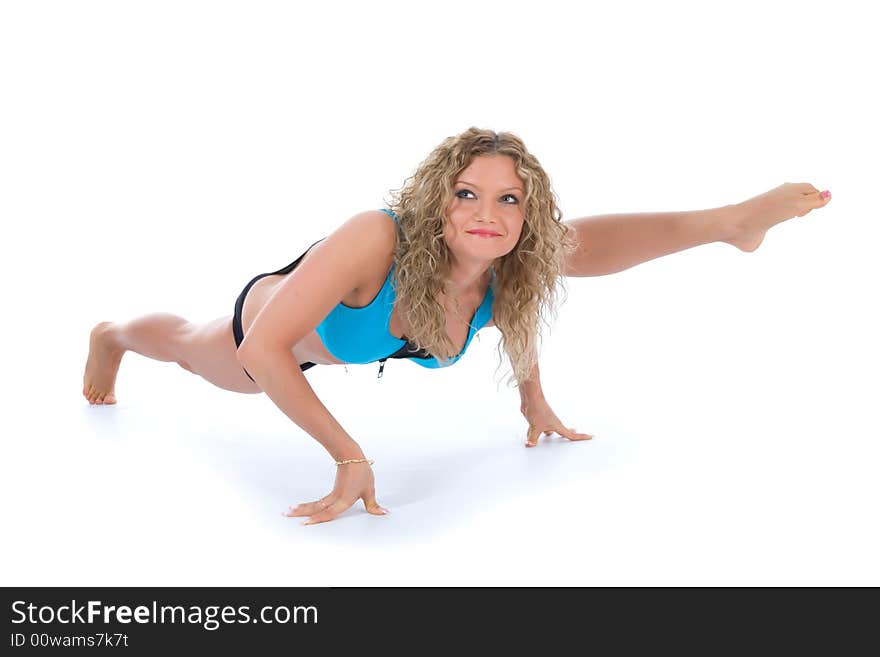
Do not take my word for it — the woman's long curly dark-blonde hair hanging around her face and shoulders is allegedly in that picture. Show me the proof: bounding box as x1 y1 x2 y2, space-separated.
388 127 577 384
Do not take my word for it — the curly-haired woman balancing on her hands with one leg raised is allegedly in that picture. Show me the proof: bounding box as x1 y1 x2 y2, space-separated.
83 128 830 524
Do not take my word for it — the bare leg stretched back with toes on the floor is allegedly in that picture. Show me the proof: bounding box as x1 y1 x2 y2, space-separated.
83 313 260 404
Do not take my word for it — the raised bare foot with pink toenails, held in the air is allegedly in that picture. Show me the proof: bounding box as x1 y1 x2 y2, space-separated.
724 183 831 252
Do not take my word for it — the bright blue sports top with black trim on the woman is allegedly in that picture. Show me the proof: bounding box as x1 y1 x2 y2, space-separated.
315 208 495 376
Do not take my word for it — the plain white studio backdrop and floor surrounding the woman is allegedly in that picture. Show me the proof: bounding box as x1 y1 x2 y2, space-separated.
0 0 880 586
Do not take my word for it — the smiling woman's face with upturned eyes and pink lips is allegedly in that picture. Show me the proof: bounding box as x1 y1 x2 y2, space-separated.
443 155 525 266
